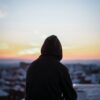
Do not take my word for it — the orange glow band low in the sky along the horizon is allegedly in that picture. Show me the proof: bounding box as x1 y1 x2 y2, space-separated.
0 46 100 60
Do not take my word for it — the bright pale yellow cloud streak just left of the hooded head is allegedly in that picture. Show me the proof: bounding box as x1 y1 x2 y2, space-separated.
18 48 40 55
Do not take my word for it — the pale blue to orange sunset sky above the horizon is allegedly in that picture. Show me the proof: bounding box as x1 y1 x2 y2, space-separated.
0 0 100 60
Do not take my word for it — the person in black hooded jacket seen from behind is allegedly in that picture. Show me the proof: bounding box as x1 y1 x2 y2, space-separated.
25 35 77 100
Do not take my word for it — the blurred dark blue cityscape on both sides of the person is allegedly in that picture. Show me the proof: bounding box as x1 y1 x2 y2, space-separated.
0 61 100 100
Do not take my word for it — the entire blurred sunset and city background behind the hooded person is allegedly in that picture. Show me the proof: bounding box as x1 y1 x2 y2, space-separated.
0 0 100 100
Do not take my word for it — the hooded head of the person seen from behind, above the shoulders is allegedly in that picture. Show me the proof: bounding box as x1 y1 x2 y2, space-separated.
41 35 62 60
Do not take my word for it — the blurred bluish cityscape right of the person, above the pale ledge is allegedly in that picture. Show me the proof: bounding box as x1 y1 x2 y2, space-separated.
65 64 100 84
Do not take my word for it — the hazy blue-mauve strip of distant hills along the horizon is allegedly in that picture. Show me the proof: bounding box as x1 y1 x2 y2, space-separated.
0 59 100 67
